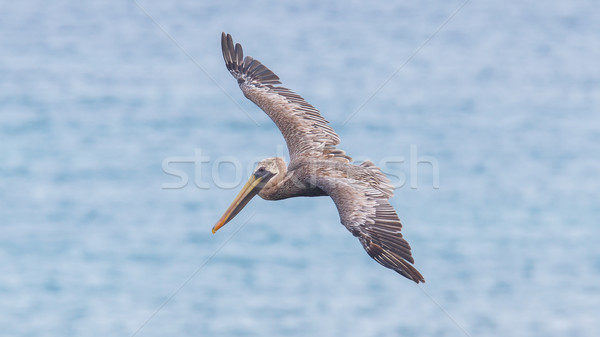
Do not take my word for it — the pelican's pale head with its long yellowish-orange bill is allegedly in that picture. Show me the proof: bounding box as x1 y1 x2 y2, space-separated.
212 157 285 234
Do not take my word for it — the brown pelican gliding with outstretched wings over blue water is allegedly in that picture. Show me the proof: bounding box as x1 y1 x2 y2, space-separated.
212 33 425 283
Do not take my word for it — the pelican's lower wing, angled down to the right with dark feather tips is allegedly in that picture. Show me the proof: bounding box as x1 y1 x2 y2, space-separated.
316 161 425 283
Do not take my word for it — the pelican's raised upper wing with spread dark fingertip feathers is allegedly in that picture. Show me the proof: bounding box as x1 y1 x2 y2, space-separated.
221 33 352 163
